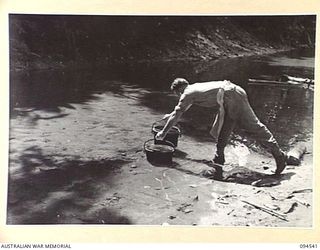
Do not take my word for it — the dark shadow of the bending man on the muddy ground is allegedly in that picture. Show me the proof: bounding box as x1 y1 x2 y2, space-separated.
150 149 294 187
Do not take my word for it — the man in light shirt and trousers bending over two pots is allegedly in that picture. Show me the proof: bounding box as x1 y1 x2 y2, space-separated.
156 78 287 178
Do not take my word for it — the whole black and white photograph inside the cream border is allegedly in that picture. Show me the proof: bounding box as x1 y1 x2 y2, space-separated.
6 13 318 229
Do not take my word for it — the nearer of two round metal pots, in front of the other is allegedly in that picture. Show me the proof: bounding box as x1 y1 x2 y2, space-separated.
144 139 175 164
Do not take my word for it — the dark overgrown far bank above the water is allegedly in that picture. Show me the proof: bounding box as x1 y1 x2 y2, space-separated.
10 14 315 70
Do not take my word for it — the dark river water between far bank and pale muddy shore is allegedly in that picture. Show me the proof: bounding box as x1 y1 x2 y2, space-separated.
10 50 314 147
